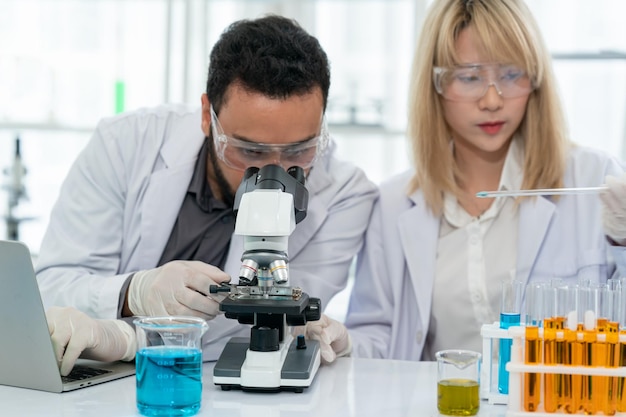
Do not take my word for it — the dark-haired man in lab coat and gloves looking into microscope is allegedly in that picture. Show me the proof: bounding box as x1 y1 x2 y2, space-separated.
37 16 376 375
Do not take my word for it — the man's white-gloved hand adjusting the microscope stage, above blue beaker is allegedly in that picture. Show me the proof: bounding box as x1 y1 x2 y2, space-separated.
127 261 230 320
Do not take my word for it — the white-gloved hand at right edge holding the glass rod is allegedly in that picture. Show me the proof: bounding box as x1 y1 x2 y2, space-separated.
600 174 626 246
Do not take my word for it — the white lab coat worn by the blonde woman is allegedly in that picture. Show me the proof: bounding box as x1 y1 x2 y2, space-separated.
346 148 626 360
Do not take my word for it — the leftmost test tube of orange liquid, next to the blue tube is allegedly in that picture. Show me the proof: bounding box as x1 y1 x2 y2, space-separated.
522 283 544 412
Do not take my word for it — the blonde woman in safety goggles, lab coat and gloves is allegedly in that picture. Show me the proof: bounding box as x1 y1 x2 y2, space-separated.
294 0 626 361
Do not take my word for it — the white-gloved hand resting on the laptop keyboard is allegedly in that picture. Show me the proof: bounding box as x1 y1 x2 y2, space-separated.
46 307 137 376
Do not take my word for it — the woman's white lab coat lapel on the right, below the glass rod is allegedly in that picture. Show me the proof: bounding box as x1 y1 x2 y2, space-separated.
517 197 555 286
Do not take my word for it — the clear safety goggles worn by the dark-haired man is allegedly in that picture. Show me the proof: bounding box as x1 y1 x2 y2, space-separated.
211 106 329 171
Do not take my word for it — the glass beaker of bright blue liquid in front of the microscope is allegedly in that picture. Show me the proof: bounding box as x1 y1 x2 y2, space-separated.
134 317 209 416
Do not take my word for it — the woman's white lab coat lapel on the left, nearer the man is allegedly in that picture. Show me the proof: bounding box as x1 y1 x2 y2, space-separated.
397 192 440 331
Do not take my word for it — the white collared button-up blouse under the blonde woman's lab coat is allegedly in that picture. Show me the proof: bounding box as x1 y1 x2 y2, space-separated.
422 138 524 360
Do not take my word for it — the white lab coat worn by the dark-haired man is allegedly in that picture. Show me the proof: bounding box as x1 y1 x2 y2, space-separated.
36 105 377 360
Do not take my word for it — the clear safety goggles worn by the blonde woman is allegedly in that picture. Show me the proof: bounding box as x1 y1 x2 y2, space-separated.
433 64 535 101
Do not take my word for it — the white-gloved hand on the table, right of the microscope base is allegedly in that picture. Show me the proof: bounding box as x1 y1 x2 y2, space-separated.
292 314 352 364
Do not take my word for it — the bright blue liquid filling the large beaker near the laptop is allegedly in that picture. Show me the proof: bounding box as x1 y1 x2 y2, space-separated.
136 346 202 416
